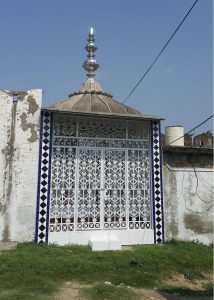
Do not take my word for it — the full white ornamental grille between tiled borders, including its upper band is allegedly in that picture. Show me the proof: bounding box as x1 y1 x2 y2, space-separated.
49 115 152 232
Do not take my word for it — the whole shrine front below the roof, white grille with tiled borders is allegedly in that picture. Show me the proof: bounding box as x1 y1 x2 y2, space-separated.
36 112 163 245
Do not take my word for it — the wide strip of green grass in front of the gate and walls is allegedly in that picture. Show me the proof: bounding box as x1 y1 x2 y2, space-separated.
0 241 213 300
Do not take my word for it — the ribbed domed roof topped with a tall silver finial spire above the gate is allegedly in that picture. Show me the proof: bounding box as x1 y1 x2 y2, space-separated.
49 27 142 116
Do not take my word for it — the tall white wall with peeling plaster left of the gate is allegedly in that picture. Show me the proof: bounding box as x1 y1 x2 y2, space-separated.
0 90 42 241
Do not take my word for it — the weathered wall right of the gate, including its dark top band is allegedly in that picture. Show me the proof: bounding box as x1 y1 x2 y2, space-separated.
163 147 214 244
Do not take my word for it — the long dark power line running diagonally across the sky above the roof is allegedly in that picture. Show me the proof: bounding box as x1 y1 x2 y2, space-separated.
123 0 198 103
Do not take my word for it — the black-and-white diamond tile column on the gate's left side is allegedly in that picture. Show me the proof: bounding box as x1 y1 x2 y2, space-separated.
36 111 52 243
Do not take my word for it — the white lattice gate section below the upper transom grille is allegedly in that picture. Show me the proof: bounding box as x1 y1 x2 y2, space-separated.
50 147 151 232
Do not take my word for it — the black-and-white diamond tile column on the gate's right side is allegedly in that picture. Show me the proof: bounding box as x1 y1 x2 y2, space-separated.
152 120 164 244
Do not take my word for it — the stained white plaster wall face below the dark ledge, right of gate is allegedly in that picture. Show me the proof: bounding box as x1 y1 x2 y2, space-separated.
163 165 214 244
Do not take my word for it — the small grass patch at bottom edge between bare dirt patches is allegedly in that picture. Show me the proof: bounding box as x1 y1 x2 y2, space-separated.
80 283 140 300
